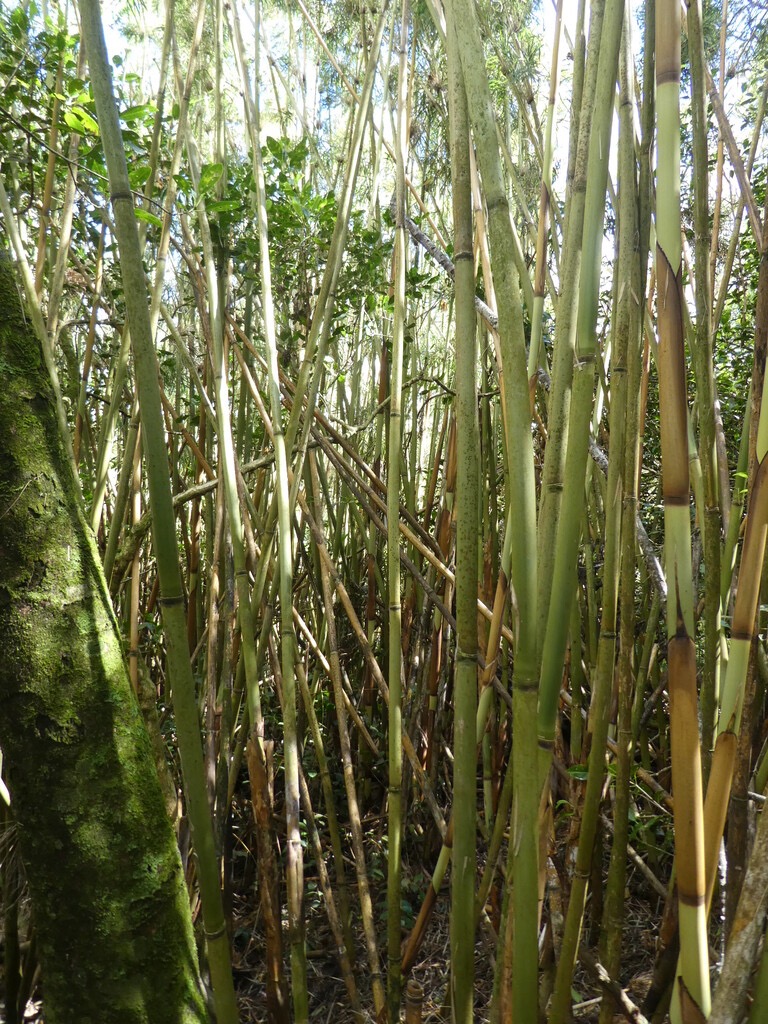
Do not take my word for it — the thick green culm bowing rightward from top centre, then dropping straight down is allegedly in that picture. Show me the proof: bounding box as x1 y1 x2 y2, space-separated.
446 0 539 1021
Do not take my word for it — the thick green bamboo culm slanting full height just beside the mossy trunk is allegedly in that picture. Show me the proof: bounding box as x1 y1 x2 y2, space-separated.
80 0 239 1024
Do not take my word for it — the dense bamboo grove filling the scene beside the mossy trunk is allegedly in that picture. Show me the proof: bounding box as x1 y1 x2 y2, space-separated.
0 0 768 1024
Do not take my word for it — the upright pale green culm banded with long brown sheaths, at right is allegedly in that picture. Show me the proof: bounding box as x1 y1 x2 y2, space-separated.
655 0 710 1024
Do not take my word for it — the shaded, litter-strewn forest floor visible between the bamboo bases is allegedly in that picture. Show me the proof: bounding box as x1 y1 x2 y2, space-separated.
0 770 672 1024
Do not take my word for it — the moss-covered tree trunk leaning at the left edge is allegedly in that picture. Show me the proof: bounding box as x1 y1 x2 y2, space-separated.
0 249 209 1024
